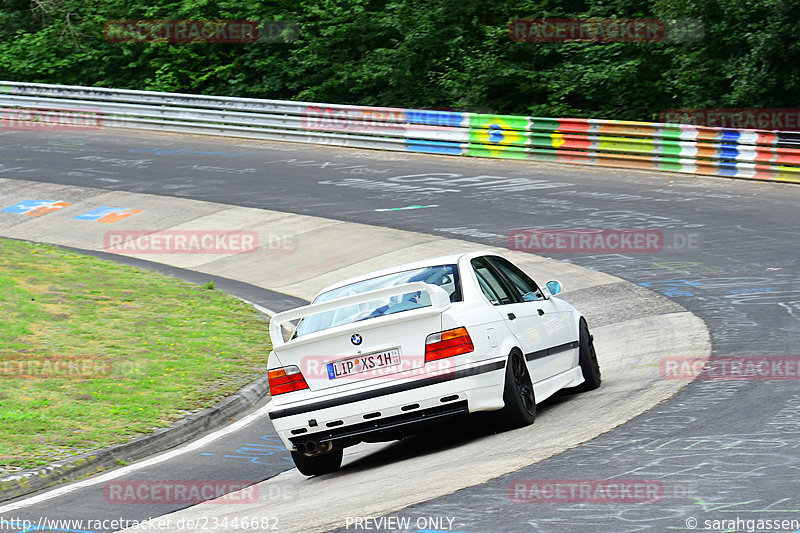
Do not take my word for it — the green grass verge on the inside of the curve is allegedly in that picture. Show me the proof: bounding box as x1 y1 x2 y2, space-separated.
0 239 269 475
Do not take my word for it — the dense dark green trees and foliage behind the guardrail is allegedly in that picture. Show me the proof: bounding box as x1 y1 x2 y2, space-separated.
0 0 800 120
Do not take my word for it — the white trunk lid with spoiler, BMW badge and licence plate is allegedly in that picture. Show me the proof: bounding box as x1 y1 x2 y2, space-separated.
270 282 450 392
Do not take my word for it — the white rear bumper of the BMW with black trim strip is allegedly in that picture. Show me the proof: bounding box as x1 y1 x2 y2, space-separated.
269 357 506 450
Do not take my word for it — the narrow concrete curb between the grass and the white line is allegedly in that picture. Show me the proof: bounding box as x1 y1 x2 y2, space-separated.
0 375 269 502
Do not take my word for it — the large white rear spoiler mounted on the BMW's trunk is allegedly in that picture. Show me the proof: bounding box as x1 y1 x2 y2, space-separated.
269 281 450 348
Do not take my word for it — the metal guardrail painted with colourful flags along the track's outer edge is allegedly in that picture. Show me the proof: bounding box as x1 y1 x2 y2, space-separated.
0 81 800 183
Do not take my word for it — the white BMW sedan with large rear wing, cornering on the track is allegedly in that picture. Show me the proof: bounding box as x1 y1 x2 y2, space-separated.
268 252 600 476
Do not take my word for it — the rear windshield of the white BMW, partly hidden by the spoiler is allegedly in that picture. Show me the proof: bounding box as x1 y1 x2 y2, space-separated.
292 265 461 338
